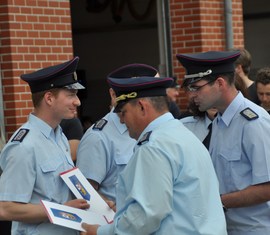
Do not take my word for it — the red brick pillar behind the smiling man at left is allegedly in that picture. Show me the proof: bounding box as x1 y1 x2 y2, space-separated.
0 0 73 137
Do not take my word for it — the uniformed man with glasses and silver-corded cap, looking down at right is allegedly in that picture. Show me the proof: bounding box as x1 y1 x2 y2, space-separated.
177 51 270 235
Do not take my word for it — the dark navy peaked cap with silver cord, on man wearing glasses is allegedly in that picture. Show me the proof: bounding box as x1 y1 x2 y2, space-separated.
176 51 240 87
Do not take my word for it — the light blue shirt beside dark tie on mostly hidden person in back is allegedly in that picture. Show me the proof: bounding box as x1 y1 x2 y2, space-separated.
180 115 212 142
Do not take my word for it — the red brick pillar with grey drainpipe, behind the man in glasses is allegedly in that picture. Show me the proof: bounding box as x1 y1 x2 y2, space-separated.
170 0 244 110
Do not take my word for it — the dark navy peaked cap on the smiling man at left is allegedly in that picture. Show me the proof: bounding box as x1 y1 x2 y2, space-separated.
21 57 84 93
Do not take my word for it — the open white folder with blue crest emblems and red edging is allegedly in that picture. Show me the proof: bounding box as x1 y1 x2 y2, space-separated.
42 167 115 231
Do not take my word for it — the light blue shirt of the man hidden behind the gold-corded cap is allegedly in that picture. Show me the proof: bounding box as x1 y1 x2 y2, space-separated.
76 110 136 201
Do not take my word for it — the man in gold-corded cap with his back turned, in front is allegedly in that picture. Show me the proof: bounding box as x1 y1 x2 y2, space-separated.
82 69 227 235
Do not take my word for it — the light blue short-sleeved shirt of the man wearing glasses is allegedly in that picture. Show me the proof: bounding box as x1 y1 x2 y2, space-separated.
209 93 270 235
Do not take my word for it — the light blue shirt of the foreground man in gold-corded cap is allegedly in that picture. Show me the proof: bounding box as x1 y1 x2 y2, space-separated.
98 113 227 235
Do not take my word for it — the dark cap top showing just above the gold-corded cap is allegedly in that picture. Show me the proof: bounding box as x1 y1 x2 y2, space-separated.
108 63 158 78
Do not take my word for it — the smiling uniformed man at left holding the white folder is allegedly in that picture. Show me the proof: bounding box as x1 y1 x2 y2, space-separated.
0 57 89 235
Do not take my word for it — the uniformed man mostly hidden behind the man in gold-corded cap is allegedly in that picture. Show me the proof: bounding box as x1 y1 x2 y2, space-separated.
77 63 157 202
